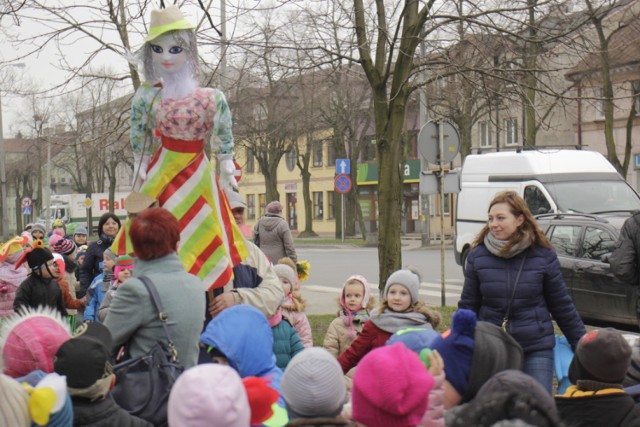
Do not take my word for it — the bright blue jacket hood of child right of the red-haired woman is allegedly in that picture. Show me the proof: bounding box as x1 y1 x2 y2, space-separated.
200 304 282 384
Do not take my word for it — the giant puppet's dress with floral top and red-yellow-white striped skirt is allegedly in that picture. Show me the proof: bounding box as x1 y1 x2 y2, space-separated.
124 84 247 289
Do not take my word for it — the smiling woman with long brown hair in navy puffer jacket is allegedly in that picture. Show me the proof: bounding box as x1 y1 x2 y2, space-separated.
458 191 586 393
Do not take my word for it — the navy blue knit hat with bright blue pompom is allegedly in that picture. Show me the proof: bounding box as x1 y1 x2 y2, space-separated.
431 309 477 396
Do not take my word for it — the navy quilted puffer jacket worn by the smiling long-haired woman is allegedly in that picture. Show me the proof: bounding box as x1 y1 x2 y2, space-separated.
458 244 586 354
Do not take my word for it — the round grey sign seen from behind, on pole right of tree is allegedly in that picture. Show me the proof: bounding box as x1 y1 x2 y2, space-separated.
418 122 460 164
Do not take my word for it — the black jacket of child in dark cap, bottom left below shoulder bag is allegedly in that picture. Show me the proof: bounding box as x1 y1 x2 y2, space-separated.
71 396 153 427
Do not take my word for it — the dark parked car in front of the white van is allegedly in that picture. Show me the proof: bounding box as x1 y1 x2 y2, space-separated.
537 212 640 326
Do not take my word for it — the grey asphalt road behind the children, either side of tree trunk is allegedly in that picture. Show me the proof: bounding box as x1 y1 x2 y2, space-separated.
296 245 463 314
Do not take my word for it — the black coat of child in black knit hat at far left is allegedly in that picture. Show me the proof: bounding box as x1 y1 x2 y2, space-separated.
13 274 67 316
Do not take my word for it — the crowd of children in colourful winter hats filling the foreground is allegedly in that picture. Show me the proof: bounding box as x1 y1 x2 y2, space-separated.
0 219 640 427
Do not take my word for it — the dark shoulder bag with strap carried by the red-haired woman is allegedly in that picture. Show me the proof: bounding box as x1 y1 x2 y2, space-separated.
111 276 184 426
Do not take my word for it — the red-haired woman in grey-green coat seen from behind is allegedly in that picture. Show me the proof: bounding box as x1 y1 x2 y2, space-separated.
104 208 205 368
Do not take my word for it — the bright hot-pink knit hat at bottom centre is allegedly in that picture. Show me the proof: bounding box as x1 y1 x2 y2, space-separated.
351 343 434 427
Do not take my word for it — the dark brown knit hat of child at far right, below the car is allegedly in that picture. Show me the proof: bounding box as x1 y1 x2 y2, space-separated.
569 328 631 384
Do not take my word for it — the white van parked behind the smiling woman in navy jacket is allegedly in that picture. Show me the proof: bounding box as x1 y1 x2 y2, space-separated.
454 150 640 266
